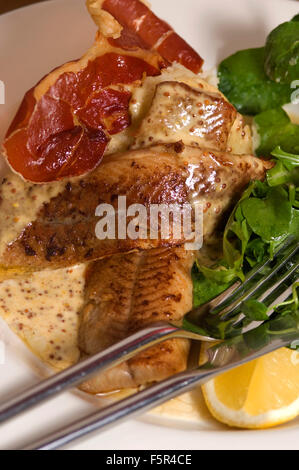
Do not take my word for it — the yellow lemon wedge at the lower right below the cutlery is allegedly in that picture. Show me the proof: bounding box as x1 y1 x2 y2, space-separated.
201 346 299 429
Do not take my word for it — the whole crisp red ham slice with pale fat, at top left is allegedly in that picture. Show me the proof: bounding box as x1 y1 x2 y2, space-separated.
3 0 202 183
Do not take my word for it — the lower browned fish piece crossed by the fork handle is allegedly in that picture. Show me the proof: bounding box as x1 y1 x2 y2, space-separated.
79 248 195 394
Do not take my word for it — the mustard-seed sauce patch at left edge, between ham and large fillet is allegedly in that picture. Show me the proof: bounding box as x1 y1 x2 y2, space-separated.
0 172 66 256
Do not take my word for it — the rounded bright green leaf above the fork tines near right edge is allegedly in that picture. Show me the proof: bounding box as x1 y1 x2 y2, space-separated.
241 186 292 242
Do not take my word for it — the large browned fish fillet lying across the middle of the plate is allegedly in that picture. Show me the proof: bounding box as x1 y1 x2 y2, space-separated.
0 143 271 270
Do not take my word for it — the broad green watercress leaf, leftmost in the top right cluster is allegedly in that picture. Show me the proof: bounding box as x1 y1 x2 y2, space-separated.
218 47 292 115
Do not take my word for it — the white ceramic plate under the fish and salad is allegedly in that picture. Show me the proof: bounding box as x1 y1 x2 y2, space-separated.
0 0 299 450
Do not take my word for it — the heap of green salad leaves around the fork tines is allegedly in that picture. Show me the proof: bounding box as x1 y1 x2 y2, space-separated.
191 158 299 341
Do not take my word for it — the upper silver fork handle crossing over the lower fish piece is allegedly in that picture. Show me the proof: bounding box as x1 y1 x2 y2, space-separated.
0 322 185 423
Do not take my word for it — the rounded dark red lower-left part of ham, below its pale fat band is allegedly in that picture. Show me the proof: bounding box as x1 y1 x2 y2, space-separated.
4 40 160 183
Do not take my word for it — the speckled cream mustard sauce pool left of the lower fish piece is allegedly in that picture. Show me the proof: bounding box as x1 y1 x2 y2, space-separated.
0 264 86 369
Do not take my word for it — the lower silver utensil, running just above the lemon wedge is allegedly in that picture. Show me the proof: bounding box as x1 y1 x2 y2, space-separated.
24 320 299 450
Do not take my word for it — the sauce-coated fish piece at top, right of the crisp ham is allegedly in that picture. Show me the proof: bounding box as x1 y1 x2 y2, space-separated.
135 81 237 151
